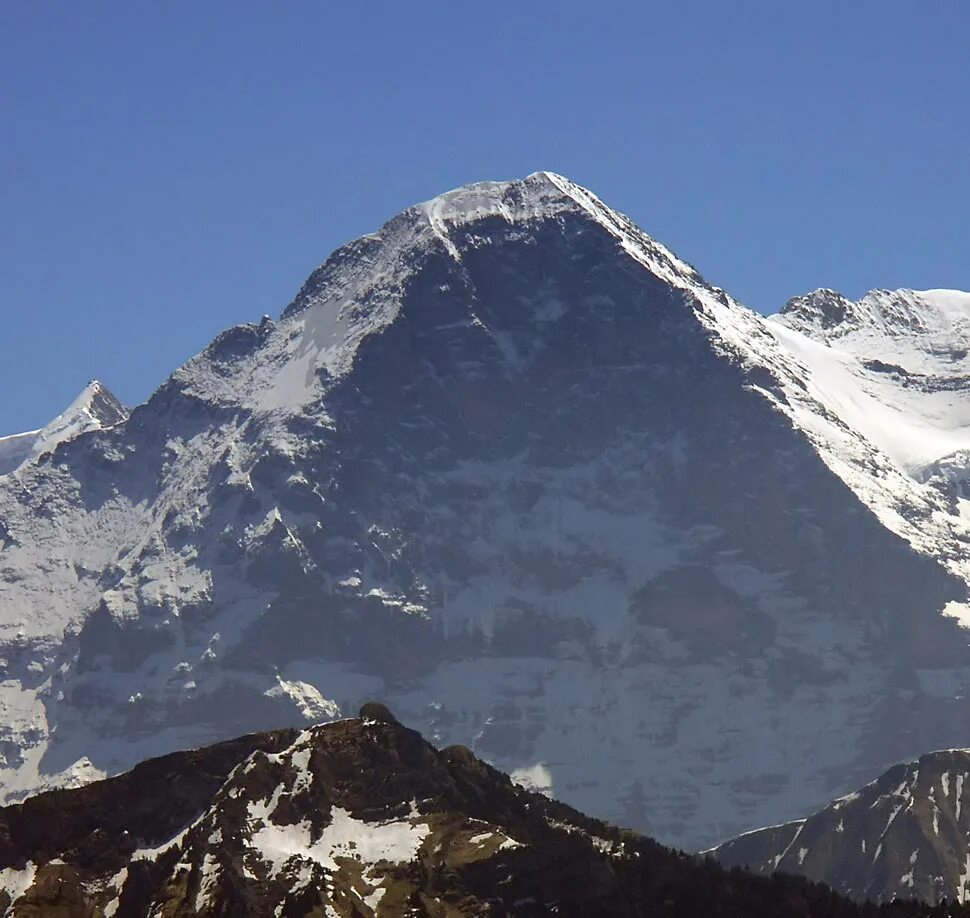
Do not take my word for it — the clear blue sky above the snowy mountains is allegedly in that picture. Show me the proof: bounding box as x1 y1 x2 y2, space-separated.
0 0 970 433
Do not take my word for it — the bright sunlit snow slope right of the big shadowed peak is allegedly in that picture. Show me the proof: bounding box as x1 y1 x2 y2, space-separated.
767 290 970 584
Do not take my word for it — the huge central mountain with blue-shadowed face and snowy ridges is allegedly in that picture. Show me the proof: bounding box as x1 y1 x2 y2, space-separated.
0 173 970 849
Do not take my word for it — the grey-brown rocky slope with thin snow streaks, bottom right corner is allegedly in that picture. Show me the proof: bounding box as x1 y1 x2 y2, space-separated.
712 749 970 903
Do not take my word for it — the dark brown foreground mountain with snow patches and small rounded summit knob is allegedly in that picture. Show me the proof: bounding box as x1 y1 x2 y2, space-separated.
0 704 970 918
